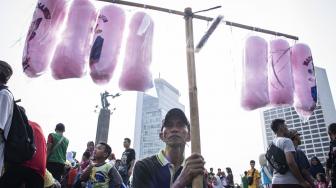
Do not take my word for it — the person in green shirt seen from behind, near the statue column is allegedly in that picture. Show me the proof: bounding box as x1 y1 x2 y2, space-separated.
47 123 69 182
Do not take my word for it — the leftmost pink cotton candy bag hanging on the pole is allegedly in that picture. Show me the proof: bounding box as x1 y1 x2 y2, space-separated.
22 0 67 77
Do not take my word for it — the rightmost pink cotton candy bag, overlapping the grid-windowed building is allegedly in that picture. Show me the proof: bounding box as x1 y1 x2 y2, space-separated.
291 43 317 117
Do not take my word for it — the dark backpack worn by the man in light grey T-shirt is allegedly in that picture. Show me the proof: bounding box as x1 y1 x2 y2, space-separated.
265 142 289 174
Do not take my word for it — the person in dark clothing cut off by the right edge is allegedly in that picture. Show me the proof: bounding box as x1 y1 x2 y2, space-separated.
326 123 336 186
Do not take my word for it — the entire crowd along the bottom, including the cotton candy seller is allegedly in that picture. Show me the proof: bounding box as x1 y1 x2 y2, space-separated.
0 61 336 188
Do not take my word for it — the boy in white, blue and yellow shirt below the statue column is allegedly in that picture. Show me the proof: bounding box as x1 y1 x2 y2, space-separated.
80 142 122 188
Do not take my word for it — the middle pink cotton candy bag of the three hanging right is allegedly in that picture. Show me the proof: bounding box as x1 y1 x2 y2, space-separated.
268 39 294 106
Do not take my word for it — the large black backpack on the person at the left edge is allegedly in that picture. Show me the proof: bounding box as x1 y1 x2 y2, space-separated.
0 86 36 164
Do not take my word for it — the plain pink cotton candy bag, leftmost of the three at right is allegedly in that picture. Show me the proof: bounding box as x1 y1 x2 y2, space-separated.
241 36 269 110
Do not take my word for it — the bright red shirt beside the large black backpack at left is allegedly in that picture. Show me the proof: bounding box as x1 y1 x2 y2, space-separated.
22 121 47 177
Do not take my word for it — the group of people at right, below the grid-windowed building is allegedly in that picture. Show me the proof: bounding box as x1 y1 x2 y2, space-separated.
241 119 336 188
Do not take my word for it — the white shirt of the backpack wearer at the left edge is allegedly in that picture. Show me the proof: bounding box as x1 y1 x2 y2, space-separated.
0 89 14 176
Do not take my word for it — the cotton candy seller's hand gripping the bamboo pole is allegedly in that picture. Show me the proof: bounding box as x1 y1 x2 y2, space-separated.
172 153 205 188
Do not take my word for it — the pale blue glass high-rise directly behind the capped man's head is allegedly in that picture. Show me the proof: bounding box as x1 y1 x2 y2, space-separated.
133 78 184 160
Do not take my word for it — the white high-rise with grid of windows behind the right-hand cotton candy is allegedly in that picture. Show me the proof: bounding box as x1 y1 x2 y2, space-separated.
261 67 336 162
